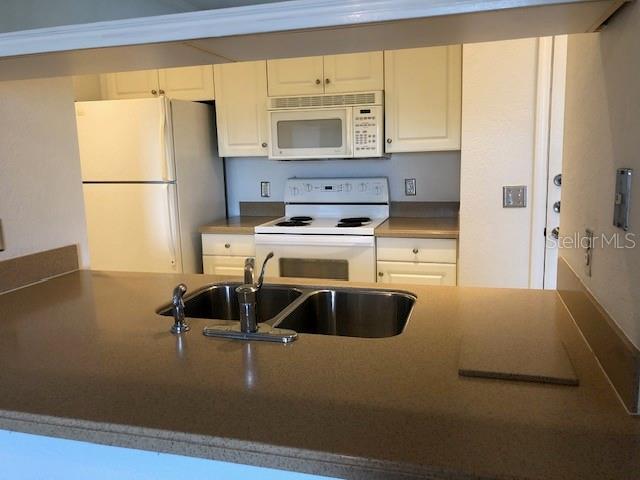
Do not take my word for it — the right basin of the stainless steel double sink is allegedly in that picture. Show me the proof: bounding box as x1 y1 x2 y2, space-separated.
274 289 416 338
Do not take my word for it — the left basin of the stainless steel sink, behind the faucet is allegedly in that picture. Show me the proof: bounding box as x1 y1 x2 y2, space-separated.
158 283 302 323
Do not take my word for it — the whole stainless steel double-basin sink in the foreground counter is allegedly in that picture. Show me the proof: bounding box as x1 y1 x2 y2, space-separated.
158 283 416 338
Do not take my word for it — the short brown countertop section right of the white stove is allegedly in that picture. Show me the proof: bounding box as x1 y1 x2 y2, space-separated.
375 217 460 238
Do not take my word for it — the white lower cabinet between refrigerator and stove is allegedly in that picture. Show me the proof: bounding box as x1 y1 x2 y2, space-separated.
202 233 256 277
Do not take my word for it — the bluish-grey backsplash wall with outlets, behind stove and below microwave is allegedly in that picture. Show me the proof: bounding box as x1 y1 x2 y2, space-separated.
226 152 460 215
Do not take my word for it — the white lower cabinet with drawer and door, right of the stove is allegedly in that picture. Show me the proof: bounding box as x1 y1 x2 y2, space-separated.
376 238 457 285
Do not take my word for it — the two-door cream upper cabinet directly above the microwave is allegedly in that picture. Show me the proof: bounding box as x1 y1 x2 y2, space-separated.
267 52 384 97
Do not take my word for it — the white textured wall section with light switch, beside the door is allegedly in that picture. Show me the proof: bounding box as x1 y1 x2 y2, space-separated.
458 39 544 288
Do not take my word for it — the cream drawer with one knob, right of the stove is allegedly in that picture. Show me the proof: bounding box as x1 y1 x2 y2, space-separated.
376 237 458 263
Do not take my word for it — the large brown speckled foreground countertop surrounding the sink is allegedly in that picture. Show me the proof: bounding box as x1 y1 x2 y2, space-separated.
0 271 640 480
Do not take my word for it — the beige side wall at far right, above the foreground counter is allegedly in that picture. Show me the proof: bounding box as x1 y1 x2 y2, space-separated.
560 2 640 347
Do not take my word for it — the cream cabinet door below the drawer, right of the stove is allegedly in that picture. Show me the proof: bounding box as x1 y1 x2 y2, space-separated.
377 262 456 285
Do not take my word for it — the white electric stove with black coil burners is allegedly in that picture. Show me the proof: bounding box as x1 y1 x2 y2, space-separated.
255 178 389 282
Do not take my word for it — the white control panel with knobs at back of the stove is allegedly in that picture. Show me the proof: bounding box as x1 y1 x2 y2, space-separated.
285 177 389 204
